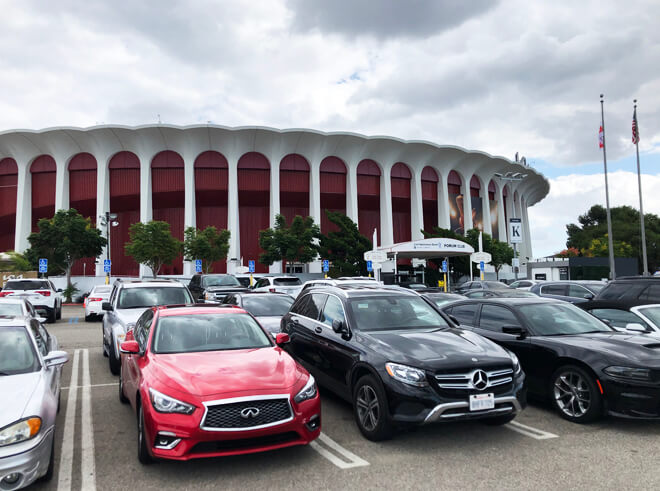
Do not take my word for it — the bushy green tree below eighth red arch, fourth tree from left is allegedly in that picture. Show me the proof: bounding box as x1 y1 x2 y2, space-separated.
259 214 321 266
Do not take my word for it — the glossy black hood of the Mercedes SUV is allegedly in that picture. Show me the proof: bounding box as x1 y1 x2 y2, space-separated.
359 329 512 370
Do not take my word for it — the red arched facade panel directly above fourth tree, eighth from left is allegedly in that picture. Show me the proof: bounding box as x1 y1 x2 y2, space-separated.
280 153 309 225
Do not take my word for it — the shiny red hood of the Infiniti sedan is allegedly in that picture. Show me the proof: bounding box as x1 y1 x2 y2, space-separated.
150 347 303 397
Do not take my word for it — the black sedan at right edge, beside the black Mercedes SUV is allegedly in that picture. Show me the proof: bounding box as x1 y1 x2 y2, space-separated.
442 298 660 423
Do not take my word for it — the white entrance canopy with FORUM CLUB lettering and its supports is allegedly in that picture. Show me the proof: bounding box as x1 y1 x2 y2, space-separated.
378 238 474 290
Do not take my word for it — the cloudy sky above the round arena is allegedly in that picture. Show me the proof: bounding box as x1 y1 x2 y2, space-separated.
0 0 660 256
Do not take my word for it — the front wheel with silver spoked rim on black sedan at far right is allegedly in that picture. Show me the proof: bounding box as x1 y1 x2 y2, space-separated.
550 365 603 424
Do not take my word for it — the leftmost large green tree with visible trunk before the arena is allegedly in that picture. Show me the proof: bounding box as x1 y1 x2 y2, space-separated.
25 208 107 301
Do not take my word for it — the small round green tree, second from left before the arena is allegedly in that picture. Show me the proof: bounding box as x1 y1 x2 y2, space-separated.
124 220 182 278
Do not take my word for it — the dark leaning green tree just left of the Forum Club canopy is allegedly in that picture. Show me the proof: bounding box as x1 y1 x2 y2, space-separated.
319 210 373 278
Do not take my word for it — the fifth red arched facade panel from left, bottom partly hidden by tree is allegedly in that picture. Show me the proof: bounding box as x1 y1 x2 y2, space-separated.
151 150 186 274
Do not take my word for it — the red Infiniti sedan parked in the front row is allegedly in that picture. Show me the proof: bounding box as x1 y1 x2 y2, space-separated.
119 307 321 464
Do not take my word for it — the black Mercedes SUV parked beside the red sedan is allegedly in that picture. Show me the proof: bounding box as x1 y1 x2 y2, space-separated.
281 285 526 441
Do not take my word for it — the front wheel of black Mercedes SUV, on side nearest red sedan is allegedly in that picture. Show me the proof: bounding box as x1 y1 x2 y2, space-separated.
353 375 392 442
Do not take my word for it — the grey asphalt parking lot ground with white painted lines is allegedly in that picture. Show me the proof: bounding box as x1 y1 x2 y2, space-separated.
35 307 660 490
